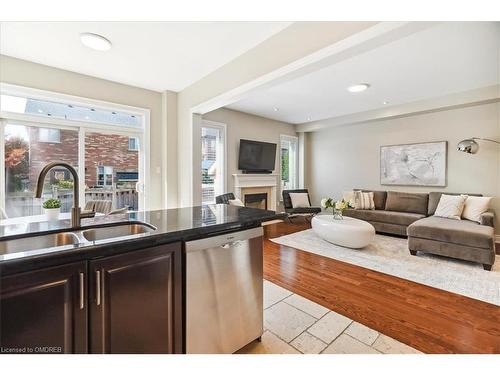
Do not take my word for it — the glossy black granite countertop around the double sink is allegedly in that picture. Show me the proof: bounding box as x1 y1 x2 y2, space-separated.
0 204 283 275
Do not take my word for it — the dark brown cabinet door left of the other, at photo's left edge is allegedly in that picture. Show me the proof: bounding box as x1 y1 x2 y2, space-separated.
0 262 88 353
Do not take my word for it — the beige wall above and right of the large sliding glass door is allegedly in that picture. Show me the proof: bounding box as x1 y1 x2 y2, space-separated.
0 55 169 209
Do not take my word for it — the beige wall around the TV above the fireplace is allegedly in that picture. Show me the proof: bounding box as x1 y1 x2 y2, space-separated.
203 108 297 206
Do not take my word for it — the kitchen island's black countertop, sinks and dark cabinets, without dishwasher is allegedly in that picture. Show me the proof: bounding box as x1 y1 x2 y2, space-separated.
0 205 280 353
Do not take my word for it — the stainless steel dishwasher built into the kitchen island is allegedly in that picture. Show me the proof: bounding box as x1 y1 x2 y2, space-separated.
185 227 263 353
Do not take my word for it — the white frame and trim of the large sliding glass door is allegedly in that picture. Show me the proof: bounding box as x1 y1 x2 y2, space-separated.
0 83 151 214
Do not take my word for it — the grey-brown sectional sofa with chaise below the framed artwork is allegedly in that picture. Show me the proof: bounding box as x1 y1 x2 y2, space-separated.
344 190 495 270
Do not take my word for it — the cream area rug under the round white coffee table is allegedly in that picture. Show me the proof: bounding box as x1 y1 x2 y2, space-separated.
272 229 500 306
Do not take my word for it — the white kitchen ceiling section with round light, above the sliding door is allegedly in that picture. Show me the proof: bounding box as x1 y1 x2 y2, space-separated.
0 22 290 91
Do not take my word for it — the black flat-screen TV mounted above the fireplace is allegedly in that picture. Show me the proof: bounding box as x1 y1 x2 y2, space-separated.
238 139 276 173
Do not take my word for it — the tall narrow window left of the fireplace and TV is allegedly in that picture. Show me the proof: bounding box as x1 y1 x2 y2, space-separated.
201 121 226 204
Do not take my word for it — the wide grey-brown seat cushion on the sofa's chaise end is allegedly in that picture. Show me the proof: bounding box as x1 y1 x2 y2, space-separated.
408 216 494 249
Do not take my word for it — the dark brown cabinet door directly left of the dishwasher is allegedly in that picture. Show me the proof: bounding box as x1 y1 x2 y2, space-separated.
89 243 182 353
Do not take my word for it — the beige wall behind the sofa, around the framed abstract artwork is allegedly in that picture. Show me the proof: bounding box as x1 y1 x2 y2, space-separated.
305 103 500 233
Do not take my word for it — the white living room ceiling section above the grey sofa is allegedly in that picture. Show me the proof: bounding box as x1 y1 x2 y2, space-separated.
228 22 500 124
